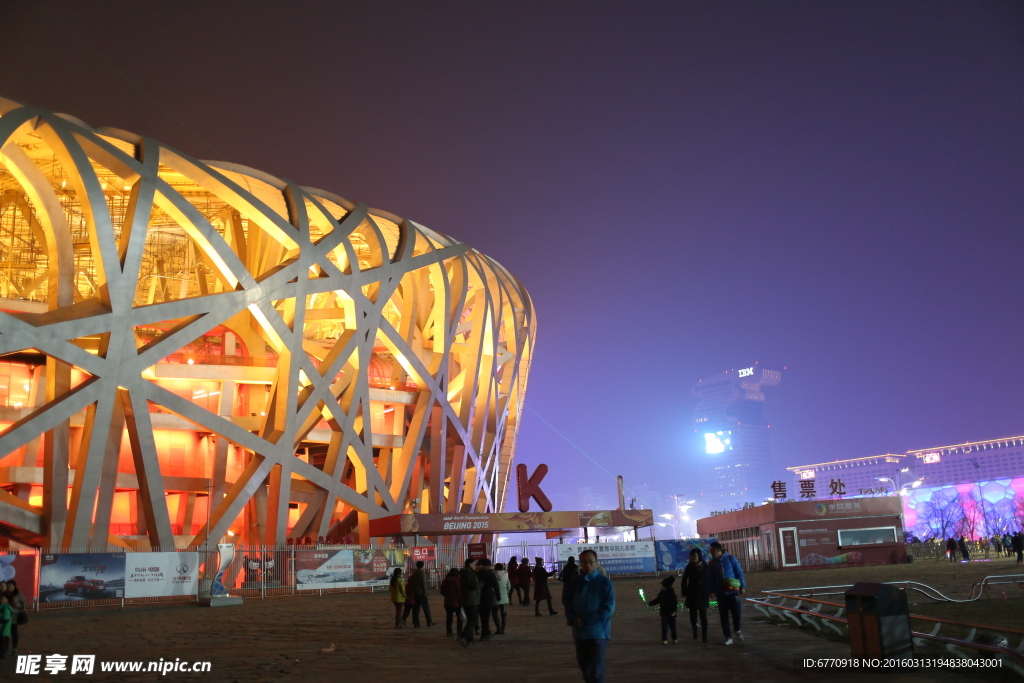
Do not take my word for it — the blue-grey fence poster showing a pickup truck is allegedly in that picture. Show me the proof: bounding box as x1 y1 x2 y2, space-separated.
39 553 125 602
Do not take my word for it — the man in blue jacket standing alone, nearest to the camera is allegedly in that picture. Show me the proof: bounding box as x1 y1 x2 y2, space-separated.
565 550 615 683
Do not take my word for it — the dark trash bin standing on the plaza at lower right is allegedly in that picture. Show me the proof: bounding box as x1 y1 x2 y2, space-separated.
844 583 913 656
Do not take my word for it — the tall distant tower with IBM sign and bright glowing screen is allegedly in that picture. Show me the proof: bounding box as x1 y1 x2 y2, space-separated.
693 364 782 513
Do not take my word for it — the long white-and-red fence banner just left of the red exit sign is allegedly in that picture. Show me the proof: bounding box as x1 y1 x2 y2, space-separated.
295 549 409 591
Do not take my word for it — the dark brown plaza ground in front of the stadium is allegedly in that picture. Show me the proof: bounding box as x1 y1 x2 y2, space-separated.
0 561 1024 683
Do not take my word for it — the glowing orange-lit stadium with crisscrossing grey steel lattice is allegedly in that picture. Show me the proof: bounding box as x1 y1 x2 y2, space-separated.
0 99 536 548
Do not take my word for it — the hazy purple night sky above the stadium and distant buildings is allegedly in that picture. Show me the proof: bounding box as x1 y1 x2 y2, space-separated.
0 2 1024 524
